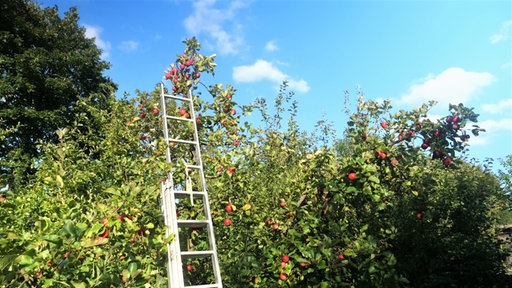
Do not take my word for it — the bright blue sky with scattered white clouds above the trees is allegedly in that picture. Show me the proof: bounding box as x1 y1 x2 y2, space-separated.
39 0 512 166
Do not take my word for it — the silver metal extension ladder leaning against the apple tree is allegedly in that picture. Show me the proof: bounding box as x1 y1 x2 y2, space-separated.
160 83 223 288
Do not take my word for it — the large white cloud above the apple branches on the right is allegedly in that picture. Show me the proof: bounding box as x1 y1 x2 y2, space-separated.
398 67 495 107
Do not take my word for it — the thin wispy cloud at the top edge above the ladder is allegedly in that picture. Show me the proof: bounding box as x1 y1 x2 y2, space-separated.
183 0 247 54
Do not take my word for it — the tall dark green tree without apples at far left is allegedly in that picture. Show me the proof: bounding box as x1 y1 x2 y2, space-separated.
0 0 115 187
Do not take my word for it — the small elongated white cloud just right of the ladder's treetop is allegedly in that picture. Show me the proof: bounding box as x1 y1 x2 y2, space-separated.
233 59 310 93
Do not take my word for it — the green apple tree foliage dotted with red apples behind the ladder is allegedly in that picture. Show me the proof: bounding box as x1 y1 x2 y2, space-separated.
0 4 510 287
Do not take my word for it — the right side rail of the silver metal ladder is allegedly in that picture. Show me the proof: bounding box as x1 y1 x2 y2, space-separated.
188 89 222 287
